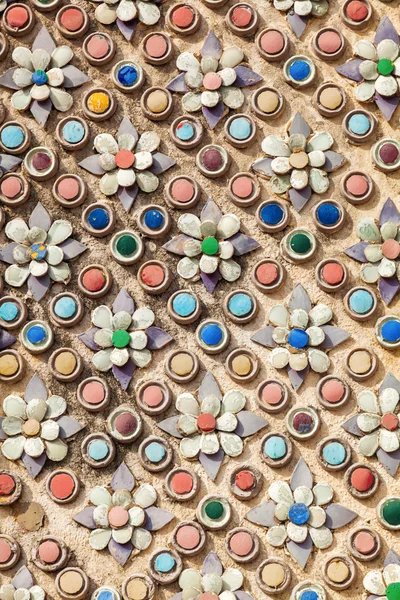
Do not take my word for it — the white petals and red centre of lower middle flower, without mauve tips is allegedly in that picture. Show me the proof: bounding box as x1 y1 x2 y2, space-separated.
176 389 246 459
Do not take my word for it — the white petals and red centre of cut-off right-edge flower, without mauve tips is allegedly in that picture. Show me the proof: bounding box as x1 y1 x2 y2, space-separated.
357 387 400 456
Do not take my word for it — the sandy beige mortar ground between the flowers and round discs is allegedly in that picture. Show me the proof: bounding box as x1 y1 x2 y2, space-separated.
0 0 400 599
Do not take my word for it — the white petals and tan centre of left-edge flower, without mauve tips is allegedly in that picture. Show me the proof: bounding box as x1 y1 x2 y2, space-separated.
1 394 68 461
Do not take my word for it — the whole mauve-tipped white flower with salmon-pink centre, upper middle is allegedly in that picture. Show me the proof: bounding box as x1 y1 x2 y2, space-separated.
167 31 262 129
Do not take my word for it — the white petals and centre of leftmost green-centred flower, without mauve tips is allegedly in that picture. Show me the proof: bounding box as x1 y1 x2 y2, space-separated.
92 305 155 371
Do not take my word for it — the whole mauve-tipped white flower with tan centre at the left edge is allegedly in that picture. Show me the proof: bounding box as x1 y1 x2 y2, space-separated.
0 374 84 478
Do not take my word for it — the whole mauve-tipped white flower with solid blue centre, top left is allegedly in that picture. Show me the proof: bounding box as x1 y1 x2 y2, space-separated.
0 27 89 127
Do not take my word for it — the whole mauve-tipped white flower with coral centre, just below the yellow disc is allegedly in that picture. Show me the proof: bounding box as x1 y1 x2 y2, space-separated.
79 116 176 211
